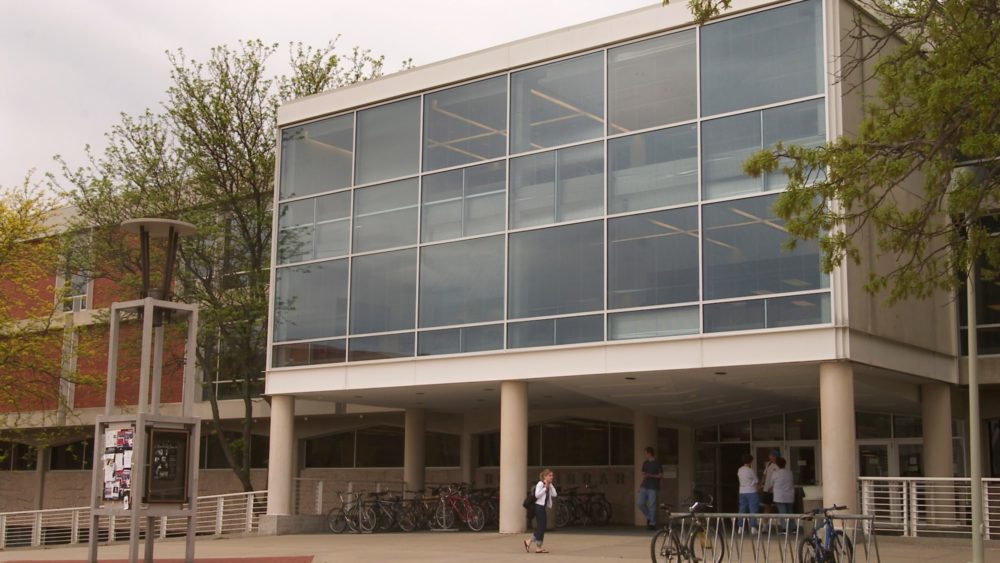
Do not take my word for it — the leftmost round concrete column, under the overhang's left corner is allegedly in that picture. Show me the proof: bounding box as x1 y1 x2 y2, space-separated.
267 395 295 516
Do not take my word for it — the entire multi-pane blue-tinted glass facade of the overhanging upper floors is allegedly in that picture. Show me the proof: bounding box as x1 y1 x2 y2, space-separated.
272 0 831 367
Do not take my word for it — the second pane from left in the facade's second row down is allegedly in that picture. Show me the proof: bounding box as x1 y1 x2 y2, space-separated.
354 178 417 252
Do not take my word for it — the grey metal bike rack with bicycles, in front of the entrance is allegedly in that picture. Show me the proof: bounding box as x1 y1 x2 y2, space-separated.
650 513 880 563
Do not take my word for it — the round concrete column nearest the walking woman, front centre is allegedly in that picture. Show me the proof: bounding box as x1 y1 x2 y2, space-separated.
500 381 528 534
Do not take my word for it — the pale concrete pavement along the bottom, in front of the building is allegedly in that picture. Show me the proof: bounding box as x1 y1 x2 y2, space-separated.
0 528 1000 563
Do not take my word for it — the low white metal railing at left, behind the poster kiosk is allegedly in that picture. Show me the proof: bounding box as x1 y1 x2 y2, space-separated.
0 491 267 549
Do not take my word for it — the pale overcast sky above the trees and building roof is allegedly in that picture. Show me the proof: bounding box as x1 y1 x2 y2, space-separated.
0 0 659 194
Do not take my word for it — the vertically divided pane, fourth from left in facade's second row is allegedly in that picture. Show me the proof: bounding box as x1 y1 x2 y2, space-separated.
510 143 604 229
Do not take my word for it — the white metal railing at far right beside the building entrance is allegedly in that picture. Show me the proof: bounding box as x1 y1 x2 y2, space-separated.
859 477 1000 539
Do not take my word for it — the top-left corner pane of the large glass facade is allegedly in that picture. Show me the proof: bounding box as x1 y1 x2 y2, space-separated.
279 114 354 199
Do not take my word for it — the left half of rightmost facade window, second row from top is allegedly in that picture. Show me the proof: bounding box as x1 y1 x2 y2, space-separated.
701 111 764 199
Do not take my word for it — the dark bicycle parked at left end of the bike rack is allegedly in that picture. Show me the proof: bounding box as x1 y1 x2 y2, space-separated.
649 496 726 563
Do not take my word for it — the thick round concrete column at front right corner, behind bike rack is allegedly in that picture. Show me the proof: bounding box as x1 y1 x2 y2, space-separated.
819 362 860 512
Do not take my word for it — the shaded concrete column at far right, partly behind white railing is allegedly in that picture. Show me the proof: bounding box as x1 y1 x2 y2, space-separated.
920 382 955 524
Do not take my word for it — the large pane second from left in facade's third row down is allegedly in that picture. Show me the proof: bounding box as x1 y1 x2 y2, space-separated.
351 249 417 334
